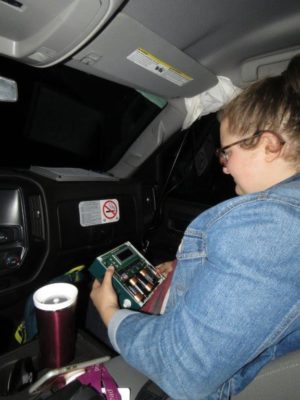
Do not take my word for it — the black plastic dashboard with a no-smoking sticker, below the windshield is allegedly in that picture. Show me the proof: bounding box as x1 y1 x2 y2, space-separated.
0 170 144 307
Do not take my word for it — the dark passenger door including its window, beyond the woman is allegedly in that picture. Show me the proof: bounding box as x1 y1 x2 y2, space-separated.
143 114 235 264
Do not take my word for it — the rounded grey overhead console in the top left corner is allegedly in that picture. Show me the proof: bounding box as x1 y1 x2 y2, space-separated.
0 0 124 67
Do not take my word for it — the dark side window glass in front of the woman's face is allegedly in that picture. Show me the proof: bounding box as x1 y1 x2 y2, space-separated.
159 114 235 206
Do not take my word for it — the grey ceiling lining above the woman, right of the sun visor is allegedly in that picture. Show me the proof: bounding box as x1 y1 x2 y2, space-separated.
125 0 300 86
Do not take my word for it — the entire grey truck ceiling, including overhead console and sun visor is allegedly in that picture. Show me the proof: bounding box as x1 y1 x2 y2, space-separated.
0 0 300 98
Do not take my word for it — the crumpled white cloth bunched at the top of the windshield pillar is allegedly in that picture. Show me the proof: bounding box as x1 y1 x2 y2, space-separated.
182 76 241 129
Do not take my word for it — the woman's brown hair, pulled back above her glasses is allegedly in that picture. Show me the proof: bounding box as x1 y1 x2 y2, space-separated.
218 54 300 167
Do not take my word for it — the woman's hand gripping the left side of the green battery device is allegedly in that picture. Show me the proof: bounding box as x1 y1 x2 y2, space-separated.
90 267 119 326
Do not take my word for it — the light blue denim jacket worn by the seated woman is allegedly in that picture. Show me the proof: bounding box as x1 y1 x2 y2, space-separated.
109 175 300 400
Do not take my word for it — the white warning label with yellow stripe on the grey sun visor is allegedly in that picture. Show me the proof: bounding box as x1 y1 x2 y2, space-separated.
127 48 193 86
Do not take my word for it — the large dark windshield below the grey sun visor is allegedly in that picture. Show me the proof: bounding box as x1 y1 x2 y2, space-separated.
0 55 161 171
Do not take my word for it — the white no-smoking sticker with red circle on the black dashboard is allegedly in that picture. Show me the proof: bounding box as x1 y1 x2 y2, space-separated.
79 199 120 226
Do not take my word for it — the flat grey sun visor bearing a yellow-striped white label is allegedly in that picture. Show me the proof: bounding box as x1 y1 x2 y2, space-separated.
67 12 217 99
